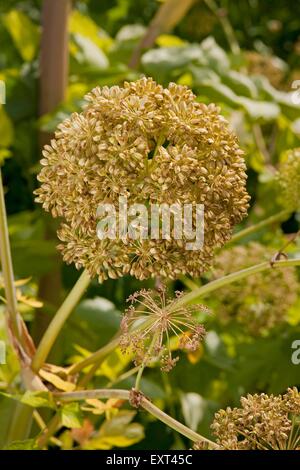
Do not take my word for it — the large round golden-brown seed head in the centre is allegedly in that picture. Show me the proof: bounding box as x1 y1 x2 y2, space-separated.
36 78 249 281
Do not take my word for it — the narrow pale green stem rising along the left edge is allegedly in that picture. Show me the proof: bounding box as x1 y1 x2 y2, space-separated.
0 169 22 342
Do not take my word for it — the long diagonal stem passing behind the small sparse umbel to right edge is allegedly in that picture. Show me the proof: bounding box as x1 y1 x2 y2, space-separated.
68 258 300 374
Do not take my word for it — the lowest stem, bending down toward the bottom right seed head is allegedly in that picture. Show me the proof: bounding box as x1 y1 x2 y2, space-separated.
56 389 218 449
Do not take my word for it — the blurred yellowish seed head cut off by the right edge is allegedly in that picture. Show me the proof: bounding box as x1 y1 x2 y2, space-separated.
277 148 300 211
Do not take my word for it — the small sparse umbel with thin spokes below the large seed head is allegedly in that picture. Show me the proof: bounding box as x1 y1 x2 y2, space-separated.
120 286 207 372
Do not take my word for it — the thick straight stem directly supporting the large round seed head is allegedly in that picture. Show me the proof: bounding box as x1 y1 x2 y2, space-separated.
31 271 91 372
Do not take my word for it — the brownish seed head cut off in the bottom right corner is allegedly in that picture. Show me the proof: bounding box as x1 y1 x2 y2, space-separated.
211 387 300 450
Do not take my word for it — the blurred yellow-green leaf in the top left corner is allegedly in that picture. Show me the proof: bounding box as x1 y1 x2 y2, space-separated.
2 10 40 62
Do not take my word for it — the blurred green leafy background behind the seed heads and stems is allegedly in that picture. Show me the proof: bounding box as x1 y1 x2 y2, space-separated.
0 0 300 449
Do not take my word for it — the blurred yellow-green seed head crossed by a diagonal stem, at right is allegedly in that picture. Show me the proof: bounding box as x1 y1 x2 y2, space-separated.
214 242 298 336
